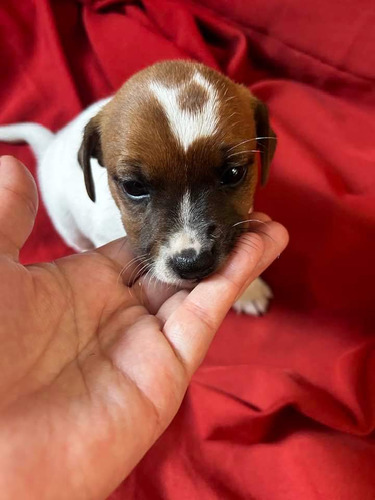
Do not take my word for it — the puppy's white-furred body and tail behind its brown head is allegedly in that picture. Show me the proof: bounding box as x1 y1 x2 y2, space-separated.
0 99 125 251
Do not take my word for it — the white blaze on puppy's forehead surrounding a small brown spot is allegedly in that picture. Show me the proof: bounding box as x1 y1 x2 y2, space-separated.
150 72 219 151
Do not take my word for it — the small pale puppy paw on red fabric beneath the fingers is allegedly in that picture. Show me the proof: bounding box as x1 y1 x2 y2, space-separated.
233 278 273 316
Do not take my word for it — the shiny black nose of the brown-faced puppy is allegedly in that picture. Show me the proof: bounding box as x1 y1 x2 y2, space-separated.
170 248 215 280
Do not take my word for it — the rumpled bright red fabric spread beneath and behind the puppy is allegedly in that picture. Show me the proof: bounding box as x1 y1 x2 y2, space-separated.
0 0 375 500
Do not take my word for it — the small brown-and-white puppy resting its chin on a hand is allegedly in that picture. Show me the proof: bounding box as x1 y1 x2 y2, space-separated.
0 61 276 315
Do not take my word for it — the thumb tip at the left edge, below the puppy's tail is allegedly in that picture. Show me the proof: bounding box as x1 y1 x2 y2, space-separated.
0 156 38 260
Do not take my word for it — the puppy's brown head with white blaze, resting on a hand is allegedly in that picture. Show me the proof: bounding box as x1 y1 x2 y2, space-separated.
78 61 276 285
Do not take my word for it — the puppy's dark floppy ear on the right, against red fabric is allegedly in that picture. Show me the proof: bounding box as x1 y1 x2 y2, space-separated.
254 99 277 186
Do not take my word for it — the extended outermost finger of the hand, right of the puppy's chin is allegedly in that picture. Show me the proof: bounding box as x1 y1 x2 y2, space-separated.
161 222 288 376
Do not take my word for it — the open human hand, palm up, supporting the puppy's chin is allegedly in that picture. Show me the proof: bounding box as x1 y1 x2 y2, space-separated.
0 157 288 500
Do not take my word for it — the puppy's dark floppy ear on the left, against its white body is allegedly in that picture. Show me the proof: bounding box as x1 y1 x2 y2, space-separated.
78 115 103 201
